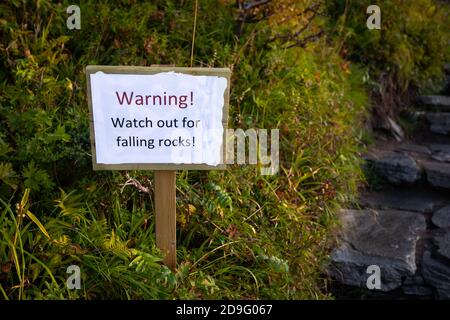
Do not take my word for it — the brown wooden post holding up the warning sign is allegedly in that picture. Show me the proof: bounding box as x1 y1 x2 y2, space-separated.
155 170 177 271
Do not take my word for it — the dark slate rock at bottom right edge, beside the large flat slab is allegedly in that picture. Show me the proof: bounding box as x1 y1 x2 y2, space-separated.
422 251 450 299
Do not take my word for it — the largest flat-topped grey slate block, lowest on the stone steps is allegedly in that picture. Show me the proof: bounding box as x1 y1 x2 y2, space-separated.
329 210 426 291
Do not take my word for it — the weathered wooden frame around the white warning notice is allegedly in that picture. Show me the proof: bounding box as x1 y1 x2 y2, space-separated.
86 65 231 170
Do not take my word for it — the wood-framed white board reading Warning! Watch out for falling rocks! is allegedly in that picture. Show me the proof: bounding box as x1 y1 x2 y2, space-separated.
86 66 230 170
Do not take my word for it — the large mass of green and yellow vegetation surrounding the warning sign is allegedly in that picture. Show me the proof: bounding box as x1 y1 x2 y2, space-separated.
0 0 446 299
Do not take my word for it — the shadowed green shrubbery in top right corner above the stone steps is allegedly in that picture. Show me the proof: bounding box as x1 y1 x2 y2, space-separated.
327 0 450 113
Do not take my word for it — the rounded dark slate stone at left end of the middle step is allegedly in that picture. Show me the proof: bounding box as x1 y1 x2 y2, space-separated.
365 150 421 184
